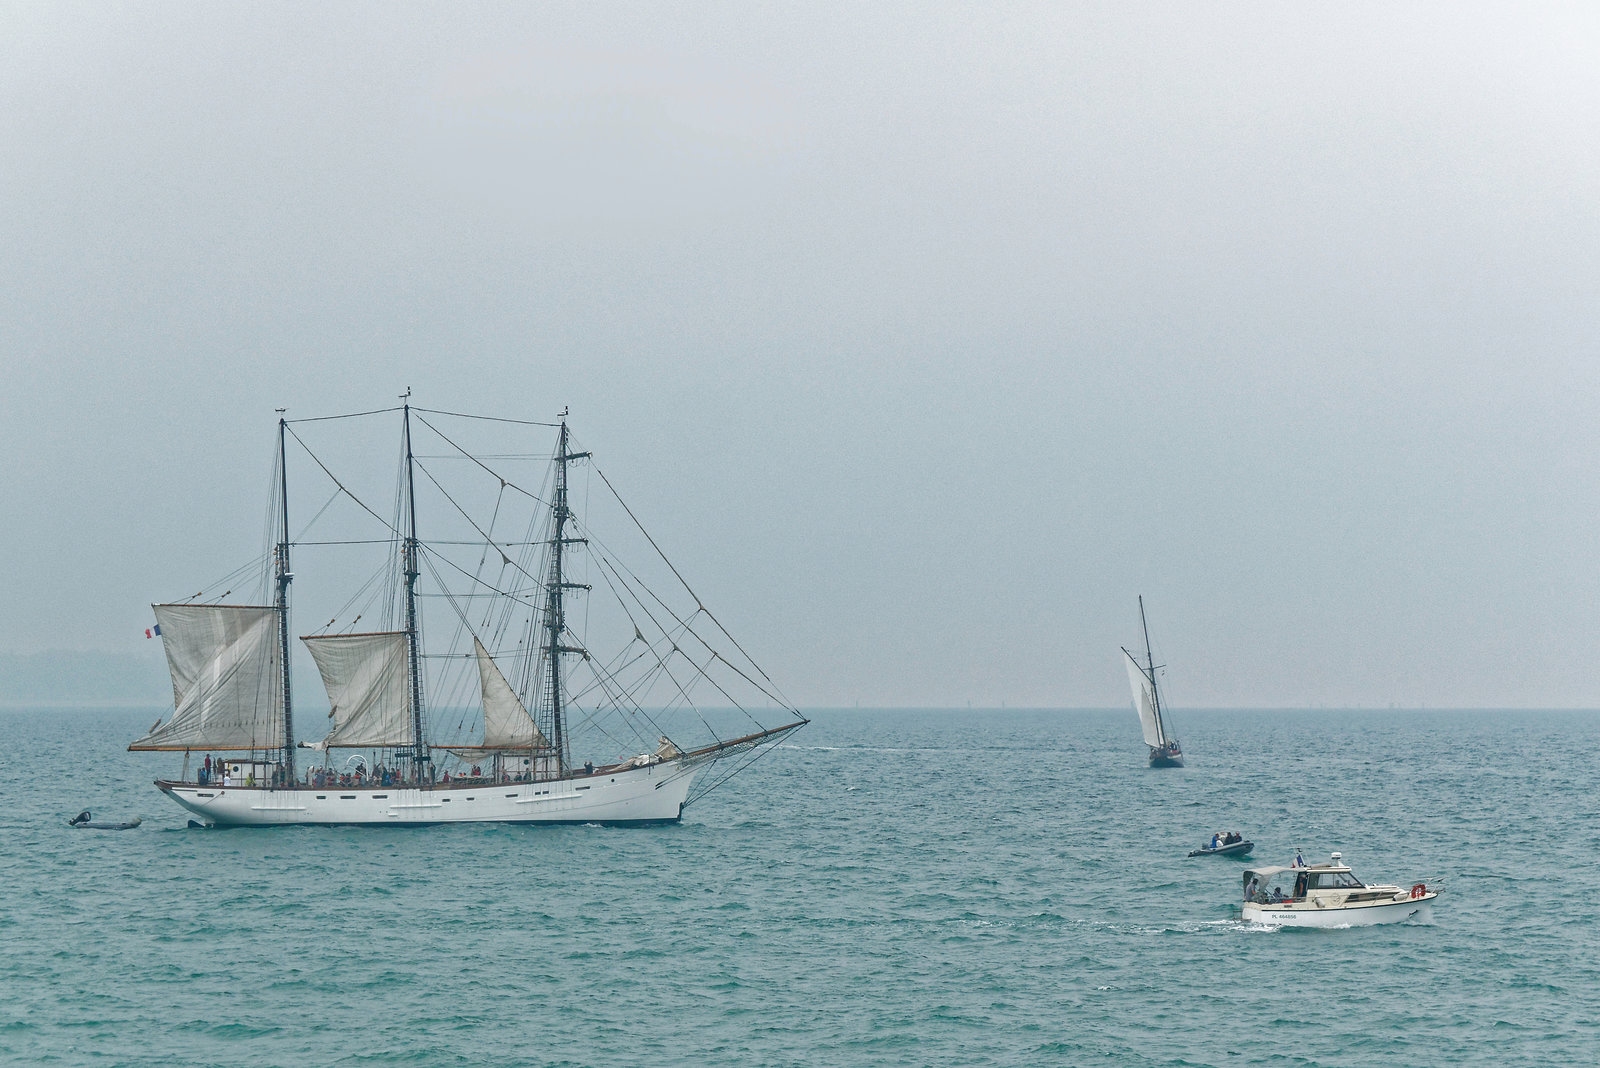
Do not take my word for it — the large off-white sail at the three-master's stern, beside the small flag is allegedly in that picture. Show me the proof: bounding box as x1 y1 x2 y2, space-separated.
128 604 283 750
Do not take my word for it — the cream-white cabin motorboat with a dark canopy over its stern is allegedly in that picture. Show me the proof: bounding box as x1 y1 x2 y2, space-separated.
1242 854 1445 927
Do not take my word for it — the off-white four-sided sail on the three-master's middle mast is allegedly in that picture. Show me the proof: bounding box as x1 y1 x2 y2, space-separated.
301 630 413 747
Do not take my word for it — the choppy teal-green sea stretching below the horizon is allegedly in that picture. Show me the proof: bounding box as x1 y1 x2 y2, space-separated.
0 710 1600 1066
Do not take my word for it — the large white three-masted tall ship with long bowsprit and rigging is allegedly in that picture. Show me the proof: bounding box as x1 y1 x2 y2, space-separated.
128 399 806 827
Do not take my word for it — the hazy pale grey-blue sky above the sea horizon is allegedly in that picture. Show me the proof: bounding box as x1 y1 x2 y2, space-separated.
0 3 1600 707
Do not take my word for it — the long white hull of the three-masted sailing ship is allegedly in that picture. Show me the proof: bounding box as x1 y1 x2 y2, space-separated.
155 761 699 827
